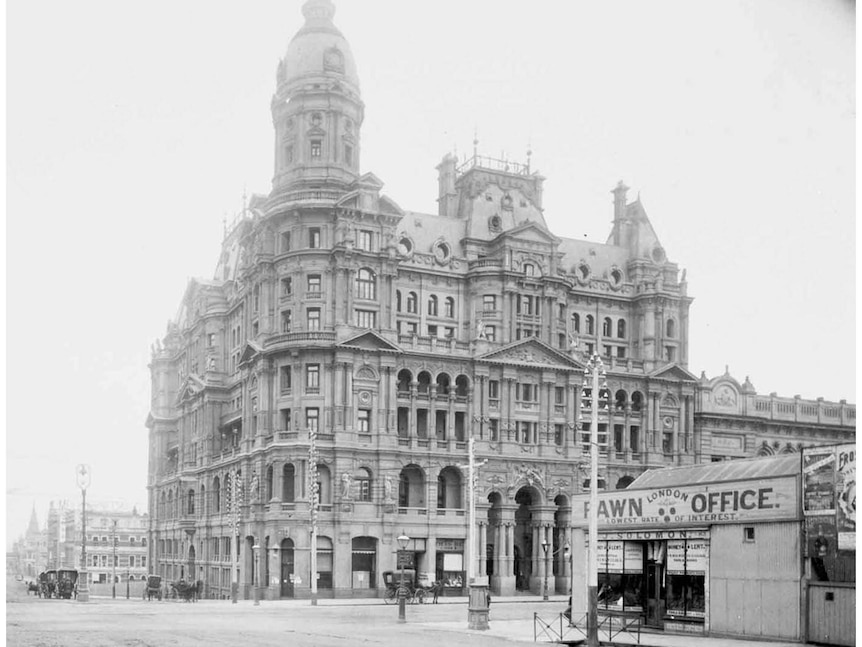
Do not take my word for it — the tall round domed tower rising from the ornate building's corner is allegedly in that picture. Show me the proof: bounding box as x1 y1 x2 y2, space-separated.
272 0 364 193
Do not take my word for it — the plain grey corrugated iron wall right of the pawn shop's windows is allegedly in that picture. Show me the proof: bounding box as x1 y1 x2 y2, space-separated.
709 521 802 640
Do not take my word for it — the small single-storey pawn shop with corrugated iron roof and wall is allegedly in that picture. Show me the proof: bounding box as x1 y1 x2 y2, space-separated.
572 454 803 640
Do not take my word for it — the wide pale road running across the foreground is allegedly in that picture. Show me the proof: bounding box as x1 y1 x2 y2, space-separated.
6 584 812 647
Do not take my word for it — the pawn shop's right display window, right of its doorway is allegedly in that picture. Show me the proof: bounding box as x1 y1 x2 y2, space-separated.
665 539 707 618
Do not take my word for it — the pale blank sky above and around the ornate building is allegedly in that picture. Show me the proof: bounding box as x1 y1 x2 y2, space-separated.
6 0 856 546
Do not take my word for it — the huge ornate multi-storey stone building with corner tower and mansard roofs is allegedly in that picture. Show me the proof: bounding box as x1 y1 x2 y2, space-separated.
147 0 855 598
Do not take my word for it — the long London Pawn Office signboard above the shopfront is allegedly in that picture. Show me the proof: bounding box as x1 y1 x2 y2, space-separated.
573 476 798 527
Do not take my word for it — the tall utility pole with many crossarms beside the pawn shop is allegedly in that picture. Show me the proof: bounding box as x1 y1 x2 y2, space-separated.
581 353 610 647
